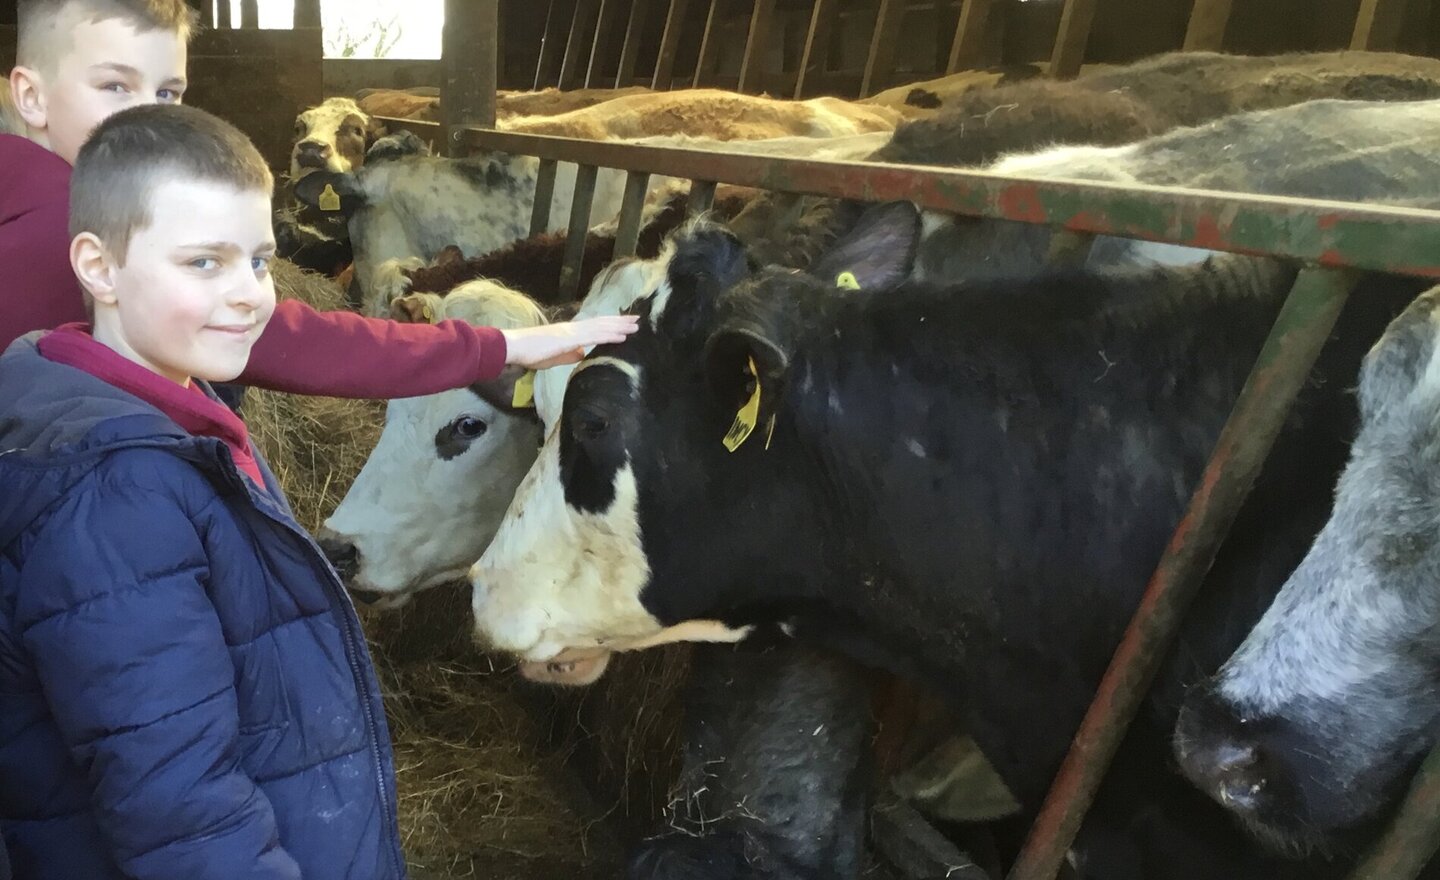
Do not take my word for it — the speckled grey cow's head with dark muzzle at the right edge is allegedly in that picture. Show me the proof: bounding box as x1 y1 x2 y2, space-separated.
1175 288 1440 850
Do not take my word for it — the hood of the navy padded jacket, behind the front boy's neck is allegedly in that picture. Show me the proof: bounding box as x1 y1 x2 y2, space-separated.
0 333 208 546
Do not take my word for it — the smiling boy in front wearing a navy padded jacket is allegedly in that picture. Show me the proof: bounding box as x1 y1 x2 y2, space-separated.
0 105 541 880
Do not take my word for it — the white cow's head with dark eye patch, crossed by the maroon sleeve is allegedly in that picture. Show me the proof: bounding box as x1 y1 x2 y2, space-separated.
320 281 544 608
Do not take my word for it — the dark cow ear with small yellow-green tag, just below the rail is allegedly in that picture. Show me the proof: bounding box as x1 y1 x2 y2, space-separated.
811 202 920 289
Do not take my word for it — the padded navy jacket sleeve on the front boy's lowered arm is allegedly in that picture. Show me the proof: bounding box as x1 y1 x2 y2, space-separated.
16 474 300 880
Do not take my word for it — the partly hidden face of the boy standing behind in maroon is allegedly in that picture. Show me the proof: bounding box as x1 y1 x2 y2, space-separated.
12 13 186 164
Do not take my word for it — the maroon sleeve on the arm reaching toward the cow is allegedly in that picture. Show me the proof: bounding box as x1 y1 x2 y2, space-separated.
238 300 505 399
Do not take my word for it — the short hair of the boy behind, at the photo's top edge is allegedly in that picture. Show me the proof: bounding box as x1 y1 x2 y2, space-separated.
14 0 200 69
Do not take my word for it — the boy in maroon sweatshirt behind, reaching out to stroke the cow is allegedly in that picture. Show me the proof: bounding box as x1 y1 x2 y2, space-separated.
0 0 624 388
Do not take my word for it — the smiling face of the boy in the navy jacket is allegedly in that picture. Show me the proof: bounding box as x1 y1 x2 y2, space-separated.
84 180 275 385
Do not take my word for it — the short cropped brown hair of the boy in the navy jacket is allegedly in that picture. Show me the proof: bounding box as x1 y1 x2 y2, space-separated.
71 104 275 265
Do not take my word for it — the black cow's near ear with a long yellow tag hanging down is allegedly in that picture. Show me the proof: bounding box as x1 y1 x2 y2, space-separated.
706 304 791 452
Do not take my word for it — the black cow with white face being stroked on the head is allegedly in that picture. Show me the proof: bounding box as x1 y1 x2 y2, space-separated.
471 212 1417 880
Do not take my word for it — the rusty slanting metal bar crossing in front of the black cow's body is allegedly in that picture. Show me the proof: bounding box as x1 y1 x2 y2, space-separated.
1008 268 1355 880
